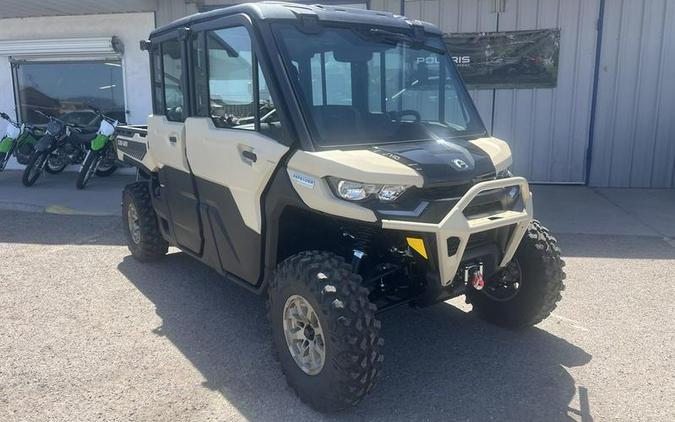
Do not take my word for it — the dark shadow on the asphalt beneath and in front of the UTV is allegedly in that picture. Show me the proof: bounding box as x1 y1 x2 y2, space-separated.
118 253 591 421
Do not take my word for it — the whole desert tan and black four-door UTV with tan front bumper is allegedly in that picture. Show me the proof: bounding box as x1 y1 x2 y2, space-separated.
116 3 564 412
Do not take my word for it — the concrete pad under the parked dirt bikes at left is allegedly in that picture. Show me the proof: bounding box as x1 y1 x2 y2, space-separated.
0 169 135 216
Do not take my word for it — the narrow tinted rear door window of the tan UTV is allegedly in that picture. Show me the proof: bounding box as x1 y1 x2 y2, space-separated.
162 39 185 122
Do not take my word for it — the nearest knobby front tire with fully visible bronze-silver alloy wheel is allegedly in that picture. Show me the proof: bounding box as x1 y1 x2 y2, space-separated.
267 251 384 412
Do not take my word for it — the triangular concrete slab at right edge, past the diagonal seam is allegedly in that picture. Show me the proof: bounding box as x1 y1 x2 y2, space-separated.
595 189 675 238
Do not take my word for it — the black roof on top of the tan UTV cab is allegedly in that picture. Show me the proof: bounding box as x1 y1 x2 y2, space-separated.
150 1 442 38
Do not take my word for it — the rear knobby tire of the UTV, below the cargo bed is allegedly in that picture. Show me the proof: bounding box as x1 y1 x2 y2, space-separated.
122 182 169 262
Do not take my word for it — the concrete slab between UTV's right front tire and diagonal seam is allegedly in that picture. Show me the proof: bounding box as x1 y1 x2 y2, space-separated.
531 185 660 237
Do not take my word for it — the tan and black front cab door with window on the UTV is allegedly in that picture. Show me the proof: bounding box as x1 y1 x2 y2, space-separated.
185 23 289 284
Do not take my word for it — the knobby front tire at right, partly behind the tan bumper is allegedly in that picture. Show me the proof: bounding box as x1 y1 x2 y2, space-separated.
466 220 565 328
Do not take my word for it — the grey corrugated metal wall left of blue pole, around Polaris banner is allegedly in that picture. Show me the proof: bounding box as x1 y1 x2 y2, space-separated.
371 0 600 183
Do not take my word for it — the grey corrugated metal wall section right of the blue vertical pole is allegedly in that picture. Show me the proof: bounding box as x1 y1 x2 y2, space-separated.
590 0 675 188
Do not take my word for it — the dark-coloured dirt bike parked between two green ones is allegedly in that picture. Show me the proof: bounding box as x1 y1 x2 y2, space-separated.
22 110 95 186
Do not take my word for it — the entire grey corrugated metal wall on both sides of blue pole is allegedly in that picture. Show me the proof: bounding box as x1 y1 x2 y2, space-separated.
370 0 675 188
